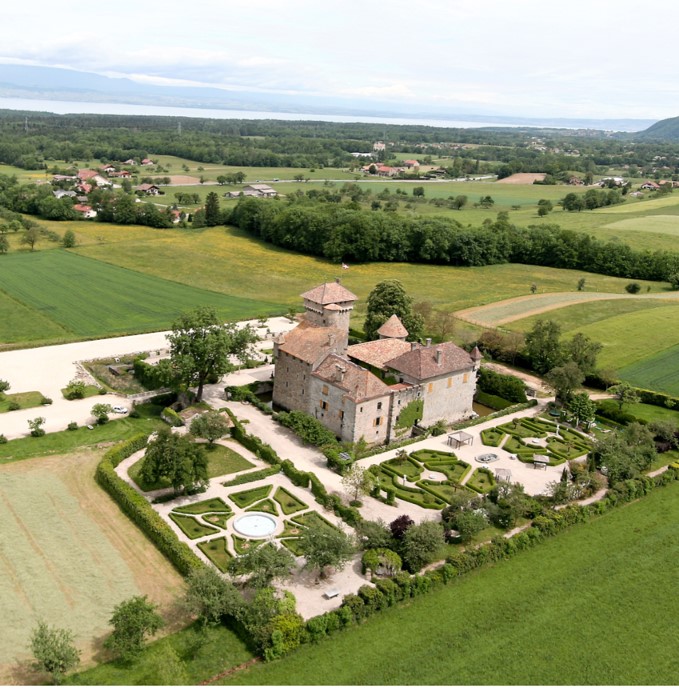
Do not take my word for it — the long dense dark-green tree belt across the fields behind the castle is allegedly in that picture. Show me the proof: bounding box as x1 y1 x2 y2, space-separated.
227 198 679 281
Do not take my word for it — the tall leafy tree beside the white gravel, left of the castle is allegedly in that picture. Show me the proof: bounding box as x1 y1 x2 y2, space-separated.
167 307 257 401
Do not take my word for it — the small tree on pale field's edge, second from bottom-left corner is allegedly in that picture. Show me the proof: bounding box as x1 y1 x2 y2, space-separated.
104 596 164 660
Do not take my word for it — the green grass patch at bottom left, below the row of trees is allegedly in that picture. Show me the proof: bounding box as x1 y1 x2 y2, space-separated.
66 624 252 686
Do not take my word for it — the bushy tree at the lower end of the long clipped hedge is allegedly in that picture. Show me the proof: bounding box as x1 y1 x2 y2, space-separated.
183 567 245 626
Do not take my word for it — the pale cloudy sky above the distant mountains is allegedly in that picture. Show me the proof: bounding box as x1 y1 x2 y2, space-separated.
0 0 679 119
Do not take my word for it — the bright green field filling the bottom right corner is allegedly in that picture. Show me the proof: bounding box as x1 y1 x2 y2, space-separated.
223 484 679 686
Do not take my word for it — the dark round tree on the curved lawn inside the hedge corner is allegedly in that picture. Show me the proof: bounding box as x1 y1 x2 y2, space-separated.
141 428 208 493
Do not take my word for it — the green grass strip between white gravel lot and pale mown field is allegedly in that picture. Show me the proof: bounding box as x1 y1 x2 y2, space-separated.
0 417 162 464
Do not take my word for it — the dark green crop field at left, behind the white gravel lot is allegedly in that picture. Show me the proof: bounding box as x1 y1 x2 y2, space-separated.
0 251 284 343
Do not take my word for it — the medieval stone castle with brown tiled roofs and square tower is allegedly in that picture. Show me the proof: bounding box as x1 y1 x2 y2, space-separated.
273 279 481 445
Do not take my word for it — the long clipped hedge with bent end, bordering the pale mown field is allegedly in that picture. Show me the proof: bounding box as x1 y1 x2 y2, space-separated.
95 434 205 576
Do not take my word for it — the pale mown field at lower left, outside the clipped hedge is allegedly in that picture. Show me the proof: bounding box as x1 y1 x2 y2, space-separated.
0 450 183 684
